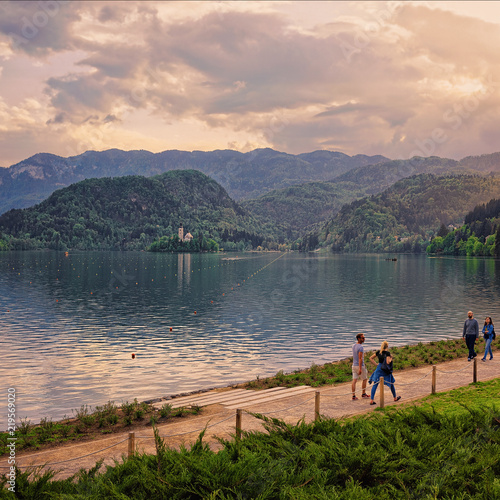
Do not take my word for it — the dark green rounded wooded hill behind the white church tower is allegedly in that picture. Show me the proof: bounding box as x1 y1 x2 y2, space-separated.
0 170 272 250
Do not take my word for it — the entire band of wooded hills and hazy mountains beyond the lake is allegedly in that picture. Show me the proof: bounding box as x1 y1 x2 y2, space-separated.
0 149 500 251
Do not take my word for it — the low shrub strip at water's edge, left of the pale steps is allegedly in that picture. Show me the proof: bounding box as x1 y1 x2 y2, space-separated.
0 399 201 455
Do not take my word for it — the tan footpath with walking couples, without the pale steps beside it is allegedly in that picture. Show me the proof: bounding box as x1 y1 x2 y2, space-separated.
0 350 500 478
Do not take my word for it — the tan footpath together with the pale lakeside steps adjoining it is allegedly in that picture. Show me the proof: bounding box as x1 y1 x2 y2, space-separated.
0 357 500 478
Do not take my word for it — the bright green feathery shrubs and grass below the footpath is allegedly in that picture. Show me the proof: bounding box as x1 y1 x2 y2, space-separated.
0 380 500 500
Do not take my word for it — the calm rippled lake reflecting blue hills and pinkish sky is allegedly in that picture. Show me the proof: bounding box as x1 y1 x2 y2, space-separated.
0 252 500 430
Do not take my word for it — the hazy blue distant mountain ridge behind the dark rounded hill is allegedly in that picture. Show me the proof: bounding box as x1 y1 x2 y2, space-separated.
0 148 388 214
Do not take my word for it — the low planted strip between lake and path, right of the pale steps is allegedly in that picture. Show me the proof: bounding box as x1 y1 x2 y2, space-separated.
243 338 496 389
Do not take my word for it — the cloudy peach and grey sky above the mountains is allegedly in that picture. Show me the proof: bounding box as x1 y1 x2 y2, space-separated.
0 0 500 167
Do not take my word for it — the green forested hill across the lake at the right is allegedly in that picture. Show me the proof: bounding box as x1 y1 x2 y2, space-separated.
303 174 500 252
